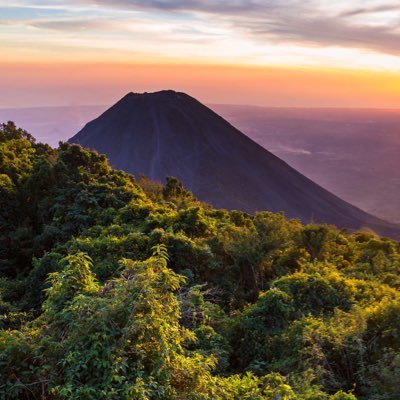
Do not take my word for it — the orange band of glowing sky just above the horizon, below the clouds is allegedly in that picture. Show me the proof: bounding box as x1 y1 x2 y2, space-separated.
0 62 400 108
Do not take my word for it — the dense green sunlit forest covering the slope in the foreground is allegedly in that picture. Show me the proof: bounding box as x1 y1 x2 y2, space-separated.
0 123 400 400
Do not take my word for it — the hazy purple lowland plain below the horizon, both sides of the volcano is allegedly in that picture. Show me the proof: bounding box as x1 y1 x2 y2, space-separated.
0 105 400 222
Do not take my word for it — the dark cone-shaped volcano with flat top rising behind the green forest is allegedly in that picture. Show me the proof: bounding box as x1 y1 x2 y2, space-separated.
69 90 400 237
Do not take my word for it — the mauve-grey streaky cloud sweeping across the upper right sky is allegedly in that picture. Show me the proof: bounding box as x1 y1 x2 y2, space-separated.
65 0 400 55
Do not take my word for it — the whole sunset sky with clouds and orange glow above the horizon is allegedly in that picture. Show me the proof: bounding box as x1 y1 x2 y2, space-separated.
0 0 400 108
